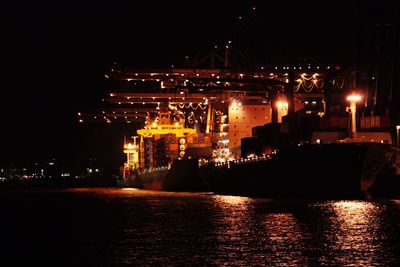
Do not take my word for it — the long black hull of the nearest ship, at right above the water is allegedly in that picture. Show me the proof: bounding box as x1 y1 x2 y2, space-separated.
200 143 395 198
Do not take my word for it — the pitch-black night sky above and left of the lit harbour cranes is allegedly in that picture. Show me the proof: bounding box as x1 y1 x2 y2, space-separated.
0 0 398 166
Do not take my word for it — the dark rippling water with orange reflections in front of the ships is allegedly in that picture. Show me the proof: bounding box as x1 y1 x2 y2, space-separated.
0 189 400 266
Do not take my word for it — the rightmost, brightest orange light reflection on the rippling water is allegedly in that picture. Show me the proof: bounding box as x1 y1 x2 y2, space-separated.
317 200 390 266
